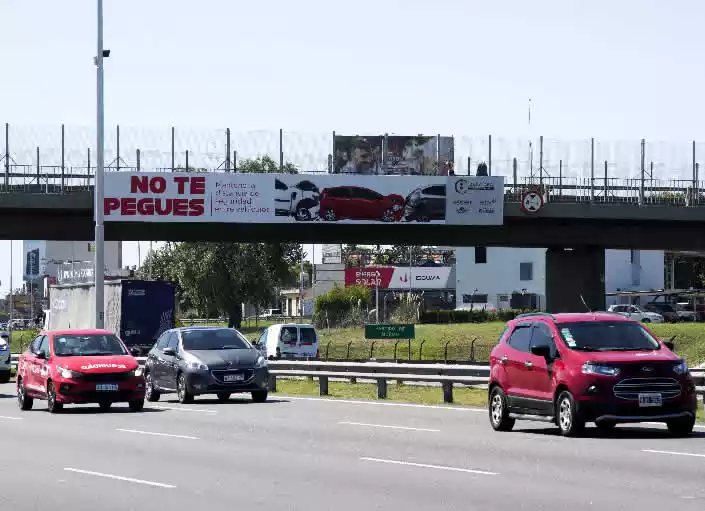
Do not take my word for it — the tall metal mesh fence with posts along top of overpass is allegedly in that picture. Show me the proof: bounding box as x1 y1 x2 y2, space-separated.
0 124 705 206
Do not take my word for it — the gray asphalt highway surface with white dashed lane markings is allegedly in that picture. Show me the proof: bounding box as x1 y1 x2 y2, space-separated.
0 384 705 511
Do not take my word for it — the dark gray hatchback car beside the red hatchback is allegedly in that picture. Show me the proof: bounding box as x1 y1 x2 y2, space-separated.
145 326 269 403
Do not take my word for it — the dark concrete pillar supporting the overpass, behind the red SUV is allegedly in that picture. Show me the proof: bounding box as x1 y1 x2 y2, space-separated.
546 246 606 313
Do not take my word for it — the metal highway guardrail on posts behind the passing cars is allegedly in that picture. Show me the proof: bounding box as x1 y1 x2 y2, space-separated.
12 353 705 403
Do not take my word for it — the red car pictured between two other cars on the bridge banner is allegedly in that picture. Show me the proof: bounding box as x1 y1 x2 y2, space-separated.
321 186 405 222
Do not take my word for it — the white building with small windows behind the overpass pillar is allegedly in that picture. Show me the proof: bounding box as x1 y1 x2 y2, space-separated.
456 247 664 308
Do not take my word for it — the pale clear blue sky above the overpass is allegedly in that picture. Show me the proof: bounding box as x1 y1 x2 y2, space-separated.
0 0 705 292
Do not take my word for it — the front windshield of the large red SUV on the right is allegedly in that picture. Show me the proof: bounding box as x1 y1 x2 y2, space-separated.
556 321 661 351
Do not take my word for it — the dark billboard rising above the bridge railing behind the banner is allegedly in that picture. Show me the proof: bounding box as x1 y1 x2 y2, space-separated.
333 135 455 176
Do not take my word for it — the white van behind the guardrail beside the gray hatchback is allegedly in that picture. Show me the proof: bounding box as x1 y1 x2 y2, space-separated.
254 323 319 360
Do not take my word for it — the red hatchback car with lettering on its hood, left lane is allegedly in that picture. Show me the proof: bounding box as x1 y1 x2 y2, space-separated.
17 330 145 413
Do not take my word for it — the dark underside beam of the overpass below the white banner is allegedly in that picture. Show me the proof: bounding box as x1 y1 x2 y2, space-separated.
0 208 705 250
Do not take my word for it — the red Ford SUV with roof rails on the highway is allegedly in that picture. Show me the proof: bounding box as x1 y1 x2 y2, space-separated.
489 312 697 436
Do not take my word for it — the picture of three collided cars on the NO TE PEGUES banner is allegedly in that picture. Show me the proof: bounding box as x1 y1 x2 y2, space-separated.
275 174 447 224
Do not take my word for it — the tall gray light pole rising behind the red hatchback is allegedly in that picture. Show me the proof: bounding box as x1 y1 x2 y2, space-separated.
93 0 109 328
